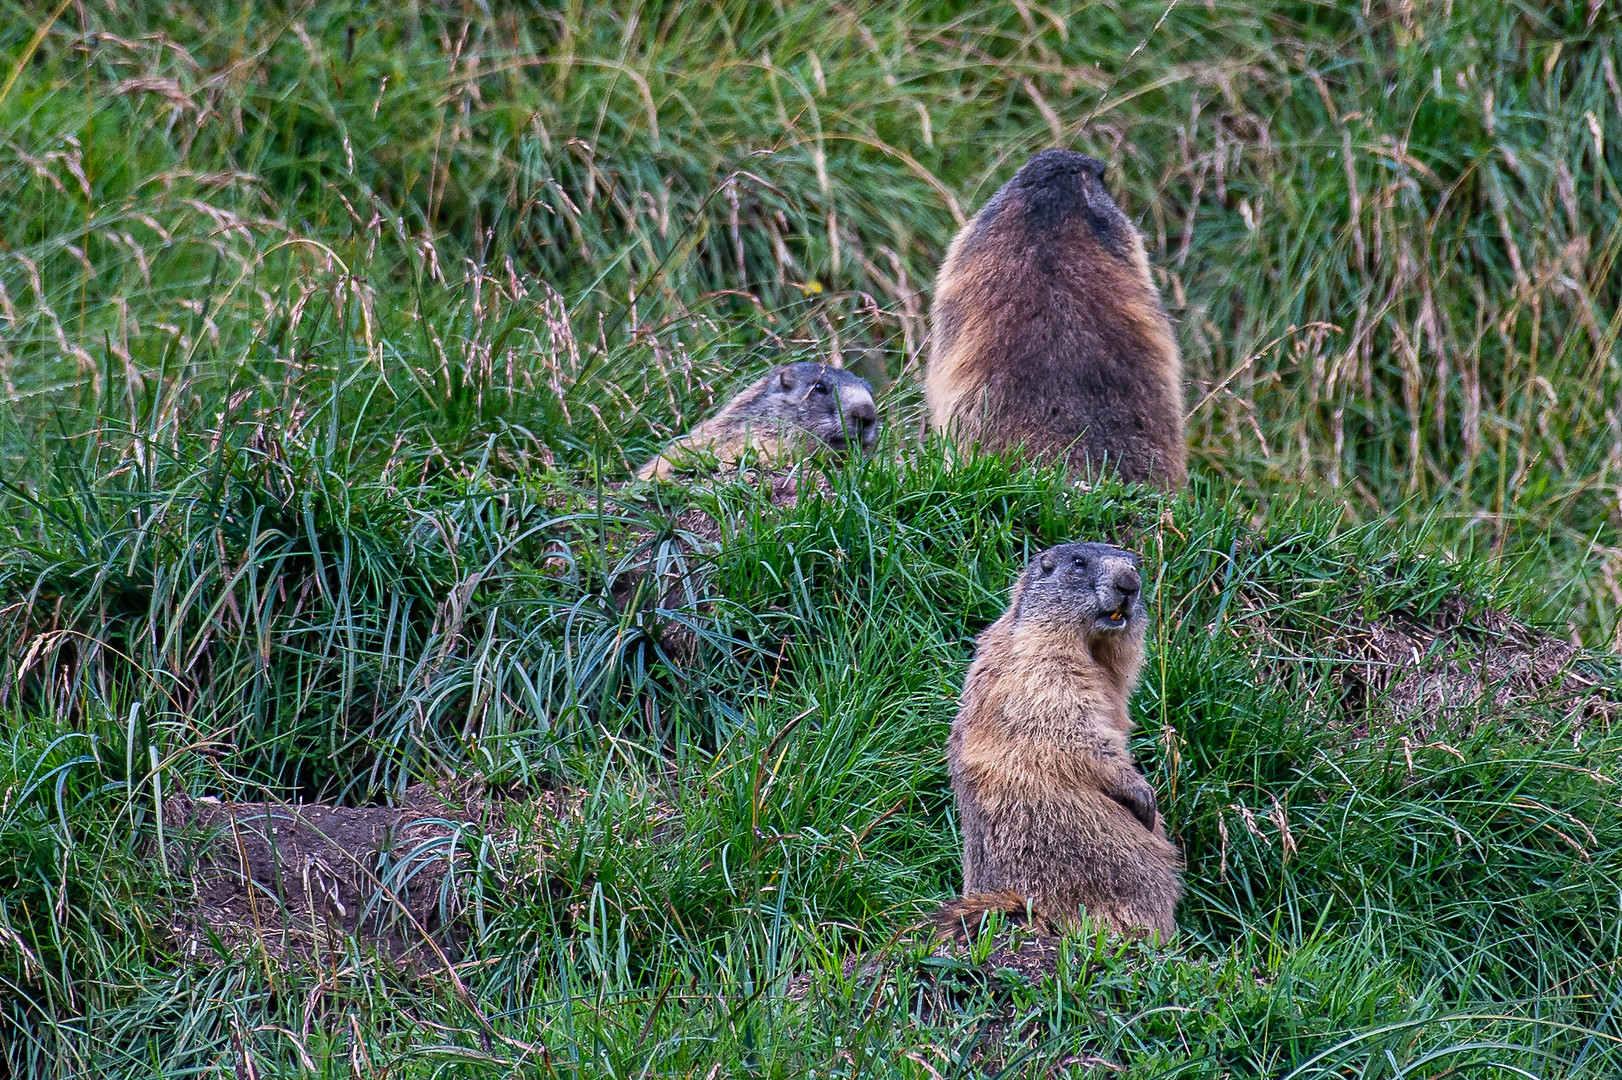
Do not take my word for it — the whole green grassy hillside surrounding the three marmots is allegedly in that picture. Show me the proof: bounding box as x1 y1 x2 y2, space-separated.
0 2 1622 1077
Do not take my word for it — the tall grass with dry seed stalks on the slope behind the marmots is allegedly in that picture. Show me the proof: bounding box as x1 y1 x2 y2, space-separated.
0 3 1622 642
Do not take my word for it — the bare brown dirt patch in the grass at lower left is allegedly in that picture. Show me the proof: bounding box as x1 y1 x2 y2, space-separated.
164 785 485 966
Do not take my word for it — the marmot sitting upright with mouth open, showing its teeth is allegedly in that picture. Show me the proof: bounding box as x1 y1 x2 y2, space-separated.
938 543 1182 939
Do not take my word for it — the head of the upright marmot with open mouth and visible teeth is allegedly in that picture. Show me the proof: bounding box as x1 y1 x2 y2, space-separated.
1014 543 1148 642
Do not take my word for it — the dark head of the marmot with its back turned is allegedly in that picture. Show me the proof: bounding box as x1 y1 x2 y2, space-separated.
965 149 1137 261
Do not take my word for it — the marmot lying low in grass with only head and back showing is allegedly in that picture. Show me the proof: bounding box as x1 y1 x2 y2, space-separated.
636 362 879 480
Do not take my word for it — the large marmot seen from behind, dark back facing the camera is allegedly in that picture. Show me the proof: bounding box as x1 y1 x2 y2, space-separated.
925 149 1187 488
